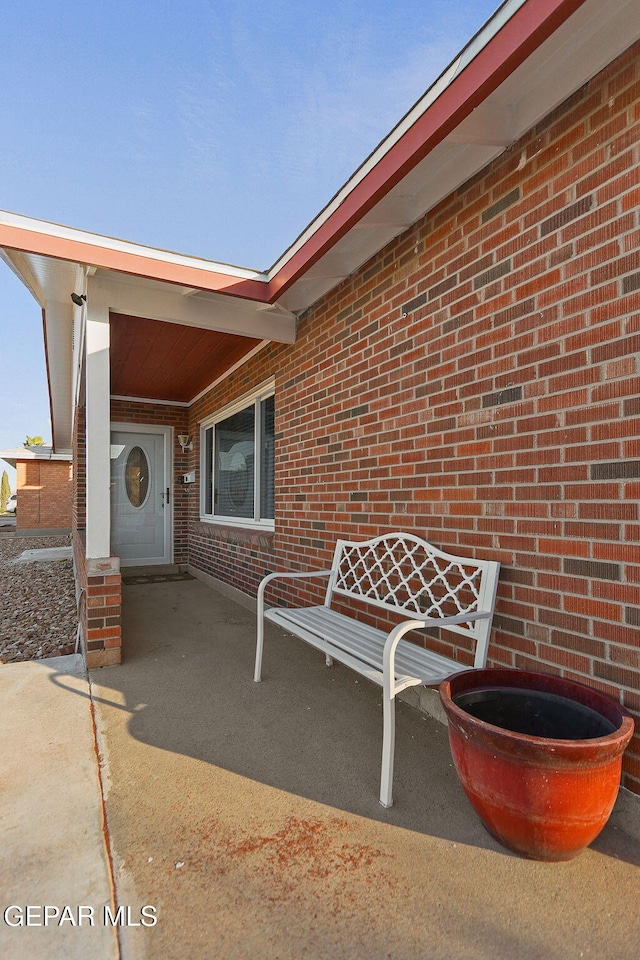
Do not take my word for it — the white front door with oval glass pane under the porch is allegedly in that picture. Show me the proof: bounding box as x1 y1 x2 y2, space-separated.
111 424 172 566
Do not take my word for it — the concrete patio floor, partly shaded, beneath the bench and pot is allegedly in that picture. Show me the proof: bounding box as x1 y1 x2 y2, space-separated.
0 580 640 960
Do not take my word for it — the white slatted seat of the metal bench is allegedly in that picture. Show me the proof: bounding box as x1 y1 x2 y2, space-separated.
265 606 463 689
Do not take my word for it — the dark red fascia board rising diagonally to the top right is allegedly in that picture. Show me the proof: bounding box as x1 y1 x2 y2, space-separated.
269 0 585 302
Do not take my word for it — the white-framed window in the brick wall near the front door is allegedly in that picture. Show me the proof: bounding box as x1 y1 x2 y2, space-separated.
200 385 275 528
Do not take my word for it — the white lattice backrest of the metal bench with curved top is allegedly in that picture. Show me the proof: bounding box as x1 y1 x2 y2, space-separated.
325 533 497 640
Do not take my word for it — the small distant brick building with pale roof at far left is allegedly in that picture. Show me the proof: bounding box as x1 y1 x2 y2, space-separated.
0 447 73 536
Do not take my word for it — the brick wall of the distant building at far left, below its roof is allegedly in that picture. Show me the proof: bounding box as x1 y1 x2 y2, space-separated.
16 460 73 531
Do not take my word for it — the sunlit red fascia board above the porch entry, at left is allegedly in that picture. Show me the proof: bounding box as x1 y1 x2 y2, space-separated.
0 224 268 303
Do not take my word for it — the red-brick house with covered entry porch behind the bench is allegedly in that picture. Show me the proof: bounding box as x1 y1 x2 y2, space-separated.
0 0 640 793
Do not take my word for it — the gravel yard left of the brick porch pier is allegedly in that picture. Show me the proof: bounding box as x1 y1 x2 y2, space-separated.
0 537 78 663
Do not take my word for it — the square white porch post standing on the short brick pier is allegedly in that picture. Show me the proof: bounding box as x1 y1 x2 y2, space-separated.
85 298 111 559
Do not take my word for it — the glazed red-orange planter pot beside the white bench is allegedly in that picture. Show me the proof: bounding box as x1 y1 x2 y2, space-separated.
440 669 633 860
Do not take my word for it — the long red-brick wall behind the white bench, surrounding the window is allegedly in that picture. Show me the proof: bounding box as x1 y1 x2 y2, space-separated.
185 39 640 792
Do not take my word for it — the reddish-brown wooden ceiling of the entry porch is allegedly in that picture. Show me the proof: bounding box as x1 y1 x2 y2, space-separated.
110 313 260 403
